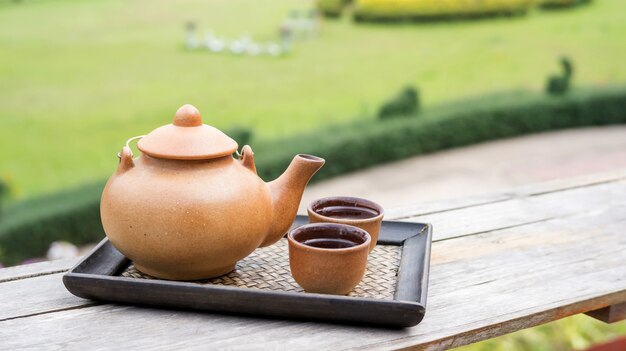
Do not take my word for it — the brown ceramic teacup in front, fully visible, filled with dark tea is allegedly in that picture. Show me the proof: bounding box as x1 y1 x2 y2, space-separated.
287 223 371 295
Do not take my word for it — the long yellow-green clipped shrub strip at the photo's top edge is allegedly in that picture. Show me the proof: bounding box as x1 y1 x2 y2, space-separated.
354 0 534 21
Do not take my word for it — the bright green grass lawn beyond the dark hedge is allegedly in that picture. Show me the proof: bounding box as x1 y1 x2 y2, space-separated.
0 0 626 198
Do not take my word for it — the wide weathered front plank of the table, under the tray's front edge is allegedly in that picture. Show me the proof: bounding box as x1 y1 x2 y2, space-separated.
0 197 626 350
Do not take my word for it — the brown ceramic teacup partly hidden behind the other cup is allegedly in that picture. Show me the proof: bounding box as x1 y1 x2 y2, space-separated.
307 196 385 252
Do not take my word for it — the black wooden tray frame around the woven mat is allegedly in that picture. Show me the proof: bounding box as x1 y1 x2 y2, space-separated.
63 216 432 327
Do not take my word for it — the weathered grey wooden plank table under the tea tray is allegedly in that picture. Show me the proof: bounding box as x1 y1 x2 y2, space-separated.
0 172 626 350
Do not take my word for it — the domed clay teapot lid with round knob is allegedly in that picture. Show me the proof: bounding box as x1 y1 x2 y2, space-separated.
137 105 238 160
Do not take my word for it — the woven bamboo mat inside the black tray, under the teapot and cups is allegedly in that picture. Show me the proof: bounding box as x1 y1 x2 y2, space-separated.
121 239 402 300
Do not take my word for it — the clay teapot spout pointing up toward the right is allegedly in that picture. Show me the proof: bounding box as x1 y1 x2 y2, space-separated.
261 154 326 247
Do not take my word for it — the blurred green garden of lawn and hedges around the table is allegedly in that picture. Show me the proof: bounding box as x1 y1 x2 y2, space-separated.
0 0 626 350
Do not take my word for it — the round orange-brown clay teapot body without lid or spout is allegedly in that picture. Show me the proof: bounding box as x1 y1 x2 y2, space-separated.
100 154 272 280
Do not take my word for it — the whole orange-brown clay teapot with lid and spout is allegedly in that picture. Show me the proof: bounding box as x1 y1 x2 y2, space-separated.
100 105 324 280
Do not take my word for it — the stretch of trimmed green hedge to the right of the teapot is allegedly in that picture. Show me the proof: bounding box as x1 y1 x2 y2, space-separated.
255 87 626 180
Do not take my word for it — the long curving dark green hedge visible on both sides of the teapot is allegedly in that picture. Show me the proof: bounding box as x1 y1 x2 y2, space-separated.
0 87 626 264
